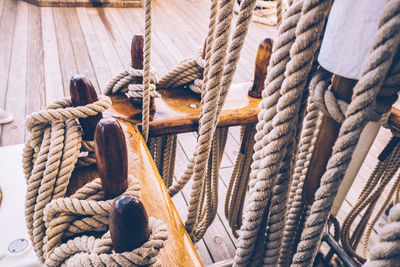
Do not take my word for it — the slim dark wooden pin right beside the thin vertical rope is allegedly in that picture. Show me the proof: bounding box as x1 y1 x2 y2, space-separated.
130 34 154 113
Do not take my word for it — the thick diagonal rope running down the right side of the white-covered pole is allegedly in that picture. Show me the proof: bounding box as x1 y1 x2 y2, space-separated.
293 0 400 266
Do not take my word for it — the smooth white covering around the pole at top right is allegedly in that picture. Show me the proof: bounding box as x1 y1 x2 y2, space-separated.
318 0 386 79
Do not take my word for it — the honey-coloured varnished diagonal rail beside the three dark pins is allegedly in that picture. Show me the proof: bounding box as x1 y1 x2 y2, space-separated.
67 121 203 266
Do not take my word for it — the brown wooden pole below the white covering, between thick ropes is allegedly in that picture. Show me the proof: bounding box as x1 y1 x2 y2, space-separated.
303 75 357 204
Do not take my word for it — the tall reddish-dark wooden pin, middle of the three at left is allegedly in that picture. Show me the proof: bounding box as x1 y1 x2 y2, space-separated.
94 118 128 199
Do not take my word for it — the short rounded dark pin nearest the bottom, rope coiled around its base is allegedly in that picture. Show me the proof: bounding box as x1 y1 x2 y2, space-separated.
109 195 150 253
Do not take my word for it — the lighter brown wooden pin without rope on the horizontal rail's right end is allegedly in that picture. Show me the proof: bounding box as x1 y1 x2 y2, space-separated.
249 38 273 98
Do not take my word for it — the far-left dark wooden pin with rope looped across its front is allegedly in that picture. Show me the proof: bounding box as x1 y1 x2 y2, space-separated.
69 74 103 141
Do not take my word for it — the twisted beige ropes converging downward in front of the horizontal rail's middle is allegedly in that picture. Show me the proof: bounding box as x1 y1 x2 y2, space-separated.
186 1 254 241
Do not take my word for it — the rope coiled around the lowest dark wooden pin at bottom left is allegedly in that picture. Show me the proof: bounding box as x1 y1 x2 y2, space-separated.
44 177 168 266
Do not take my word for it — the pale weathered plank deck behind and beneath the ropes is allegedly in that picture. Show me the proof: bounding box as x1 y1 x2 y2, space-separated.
0 0 396 265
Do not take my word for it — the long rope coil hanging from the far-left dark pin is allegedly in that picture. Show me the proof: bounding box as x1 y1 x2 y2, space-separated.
23 96 111 262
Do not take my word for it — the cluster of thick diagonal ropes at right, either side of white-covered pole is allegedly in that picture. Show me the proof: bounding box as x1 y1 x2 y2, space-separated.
235 0 400 266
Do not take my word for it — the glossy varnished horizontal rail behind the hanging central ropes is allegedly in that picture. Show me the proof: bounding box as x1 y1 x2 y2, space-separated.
107 83 260 136
